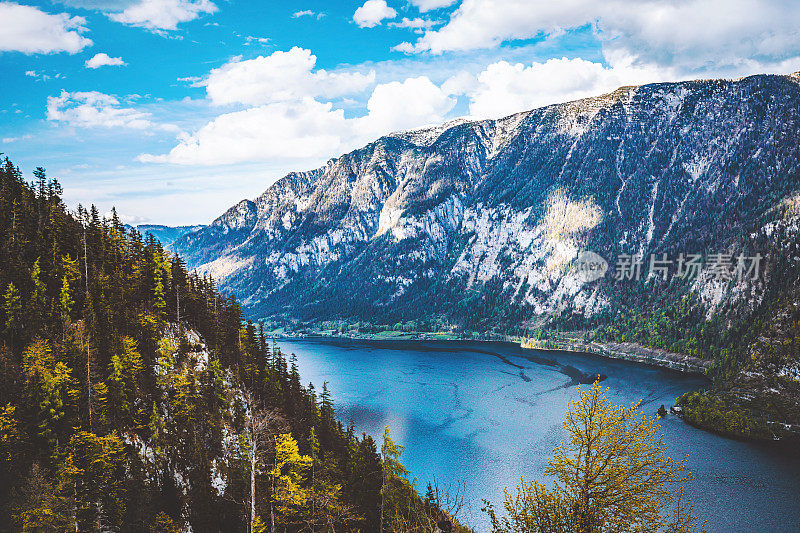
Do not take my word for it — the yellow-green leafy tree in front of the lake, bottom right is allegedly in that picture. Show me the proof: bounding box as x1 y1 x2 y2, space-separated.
485 384 703 533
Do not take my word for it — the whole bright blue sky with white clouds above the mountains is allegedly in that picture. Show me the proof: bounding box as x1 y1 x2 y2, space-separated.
0 0 800 224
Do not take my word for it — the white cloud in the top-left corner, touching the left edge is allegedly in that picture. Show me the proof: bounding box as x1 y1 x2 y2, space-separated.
0 2 92 54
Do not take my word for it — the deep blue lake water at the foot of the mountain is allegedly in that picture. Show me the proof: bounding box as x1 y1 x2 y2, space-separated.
279 339 800 533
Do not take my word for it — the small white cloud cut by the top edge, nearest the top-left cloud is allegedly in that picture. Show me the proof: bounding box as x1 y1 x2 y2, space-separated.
108 0 217 31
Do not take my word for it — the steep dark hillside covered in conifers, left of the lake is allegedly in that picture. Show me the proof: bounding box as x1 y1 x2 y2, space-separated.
0 159 462 533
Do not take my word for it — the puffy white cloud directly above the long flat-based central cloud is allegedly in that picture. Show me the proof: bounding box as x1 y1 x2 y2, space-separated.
202 47 375 105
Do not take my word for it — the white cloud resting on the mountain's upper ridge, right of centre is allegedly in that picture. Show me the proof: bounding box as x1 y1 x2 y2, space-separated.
462 58 663 118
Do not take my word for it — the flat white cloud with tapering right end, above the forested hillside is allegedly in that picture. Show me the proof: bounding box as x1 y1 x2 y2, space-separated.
47 91 178 132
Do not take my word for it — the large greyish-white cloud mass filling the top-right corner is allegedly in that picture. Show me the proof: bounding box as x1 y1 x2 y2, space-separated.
399 0 800 74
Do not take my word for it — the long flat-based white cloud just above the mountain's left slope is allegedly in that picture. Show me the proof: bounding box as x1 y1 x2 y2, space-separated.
139 77 455 165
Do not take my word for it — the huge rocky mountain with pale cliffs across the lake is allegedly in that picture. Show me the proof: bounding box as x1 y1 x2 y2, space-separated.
173 73 800 440
